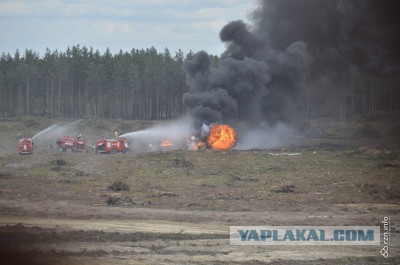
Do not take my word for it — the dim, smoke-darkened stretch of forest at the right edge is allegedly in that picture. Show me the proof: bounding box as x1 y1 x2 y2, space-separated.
301 67 400 119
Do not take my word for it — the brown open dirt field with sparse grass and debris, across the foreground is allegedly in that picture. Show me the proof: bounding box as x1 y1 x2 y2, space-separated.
0 114 400 264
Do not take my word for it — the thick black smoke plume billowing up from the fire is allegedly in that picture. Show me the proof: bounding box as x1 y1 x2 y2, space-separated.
183 0 400 123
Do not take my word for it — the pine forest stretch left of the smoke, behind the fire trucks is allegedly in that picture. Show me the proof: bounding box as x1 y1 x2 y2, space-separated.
0 45 217 119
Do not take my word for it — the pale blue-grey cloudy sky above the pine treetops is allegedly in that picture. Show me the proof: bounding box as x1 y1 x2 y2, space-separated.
0 0 255 55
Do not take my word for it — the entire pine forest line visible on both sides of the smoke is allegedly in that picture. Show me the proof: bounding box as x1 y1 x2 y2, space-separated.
0 45 400 120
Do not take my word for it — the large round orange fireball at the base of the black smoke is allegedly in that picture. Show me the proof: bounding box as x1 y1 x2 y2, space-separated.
207 124 236 151
